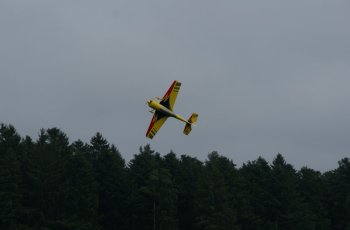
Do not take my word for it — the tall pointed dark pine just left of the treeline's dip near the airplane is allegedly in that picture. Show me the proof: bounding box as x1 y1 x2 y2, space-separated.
90 133 127 229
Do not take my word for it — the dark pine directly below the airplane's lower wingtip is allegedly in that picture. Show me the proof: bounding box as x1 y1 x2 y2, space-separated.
129 145 177 229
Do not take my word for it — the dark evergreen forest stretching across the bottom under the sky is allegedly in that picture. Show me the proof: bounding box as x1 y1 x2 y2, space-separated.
0 124 350 230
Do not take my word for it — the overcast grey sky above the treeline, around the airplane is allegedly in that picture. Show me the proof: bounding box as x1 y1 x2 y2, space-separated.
0 0 350 171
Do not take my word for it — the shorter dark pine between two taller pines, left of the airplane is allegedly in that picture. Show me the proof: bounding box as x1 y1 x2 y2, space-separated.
62 141 99 229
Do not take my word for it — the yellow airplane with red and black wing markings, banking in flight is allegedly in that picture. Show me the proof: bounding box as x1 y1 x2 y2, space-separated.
146 81 198 139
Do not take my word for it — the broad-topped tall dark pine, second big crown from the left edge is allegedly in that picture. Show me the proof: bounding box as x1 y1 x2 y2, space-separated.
21 128 71 229
